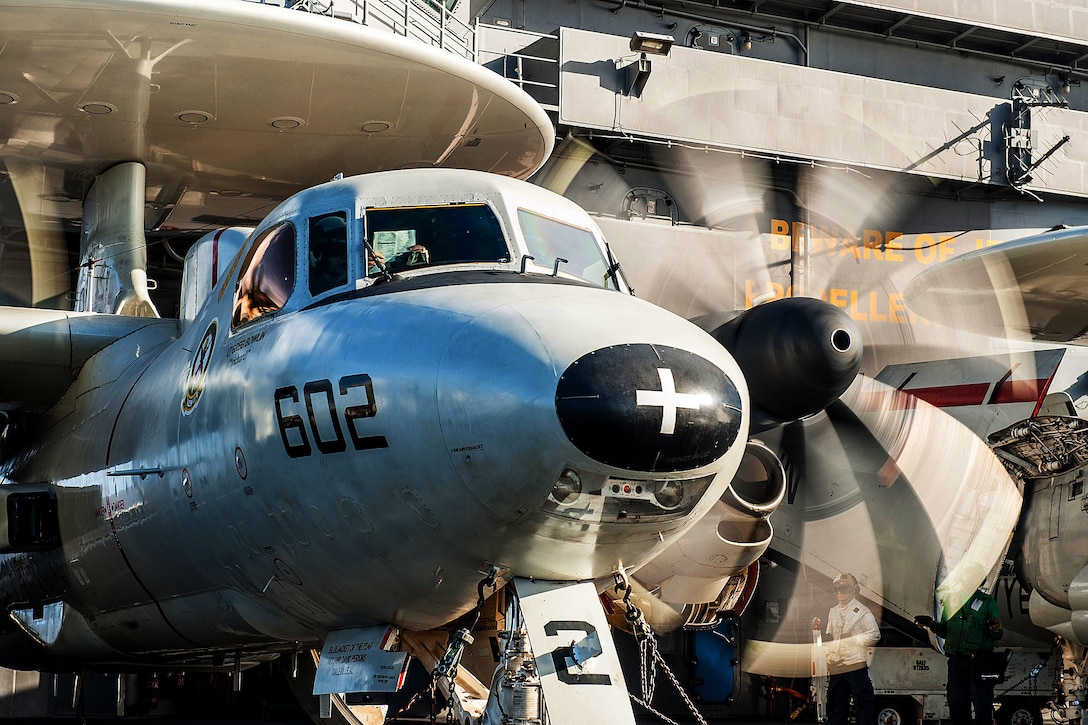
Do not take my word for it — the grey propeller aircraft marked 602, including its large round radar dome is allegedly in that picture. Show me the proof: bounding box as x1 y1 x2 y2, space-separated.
0 0 874 724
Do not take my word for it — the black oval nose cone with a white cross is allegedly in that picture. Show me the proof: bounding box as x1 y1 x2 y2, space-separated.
555 344 742 472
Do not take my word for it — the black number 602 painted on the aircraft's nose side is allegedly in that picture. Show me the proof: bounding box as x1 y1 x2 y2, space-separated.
275 373 390 458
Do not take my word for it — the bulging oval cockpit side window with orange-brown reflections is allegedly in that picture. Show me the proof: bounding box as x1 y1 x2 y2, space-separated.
231 222 295 327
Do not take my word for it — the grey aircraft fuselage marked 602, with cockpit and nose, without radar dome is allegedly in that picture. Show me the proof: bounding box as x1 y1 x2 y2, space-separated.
0 165 770 722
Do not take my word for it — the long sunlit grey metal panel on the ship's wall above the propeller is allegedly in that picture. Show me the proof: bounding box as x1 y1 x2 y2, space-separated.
559 28 1088 196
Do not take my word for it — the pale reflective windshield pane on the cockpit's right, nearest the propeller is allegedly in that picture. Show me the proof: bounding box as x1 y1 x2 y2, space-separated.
518 209 616 290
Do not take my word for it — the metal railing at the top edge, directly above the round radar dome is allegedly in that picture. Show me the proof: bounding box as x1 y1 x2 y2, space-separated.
247 0 477 61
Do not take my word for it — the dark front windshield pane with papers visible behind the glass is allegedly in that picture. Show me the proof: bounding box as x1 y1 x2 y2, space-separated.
367 204 510 277
